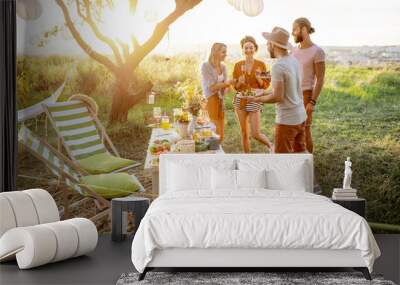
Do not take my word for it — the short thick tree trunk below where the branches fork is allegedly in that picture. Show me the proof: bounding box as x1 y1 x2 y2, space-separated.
109 76 153 125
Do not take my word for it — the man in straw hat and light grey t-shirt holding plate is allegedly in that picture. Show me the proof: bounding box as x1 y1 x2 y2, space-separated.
248 27 307 153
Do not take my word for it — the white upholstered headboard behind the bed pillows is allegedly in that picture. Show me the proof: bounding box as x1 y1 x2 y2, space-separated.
159 153 314 195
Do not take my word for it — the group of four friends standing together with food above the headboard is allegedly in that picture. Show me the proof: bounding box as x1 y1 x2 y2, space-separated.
201 18 325 153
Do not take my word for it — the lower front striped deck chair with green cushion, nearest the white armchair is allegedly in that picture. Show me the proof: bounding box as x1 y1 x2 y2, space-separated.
18 126 144 221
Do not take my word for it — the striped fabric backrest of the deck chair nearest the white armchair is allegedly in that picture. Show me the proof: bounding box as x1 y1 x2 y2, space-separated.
18 126 83 195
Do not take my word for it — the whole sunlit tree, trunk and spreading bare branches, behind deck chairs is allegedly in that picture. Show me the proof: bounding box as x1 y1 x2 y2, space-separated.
56 0 202 124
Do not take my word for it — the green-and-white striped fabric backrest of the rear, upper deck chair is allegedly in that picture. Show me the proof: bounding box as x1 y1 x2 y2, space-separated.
45 101 107 160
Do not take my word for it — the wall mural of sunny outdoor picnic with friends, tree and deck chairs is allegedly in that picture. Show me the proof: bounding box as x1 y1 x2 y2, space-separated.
17 0 400 232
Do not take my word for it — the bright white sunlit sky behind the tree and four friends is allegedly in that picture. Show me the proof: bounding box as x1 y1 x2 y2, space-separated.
17 0 400 55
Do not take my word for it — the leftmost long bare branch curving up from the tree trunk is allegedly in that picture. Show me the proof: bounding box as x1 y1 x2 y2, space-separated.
56 0 118 74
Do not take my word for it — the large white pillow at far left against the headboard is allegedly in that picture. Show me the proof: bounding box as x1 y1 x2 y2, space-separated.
167 163 212 191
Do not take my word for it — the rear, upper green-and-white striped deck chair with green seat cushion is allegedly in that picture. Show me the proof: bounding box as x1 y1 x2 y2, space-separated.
43 100 140 174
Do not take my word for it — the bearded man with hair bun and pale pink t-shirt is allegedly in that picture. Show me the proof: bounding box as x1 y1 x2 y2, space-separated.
292 18 325 153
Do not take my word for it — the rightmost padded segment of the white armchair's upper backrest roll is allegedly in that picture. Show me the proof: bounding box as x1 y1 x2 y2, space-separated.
23 189 60 224
